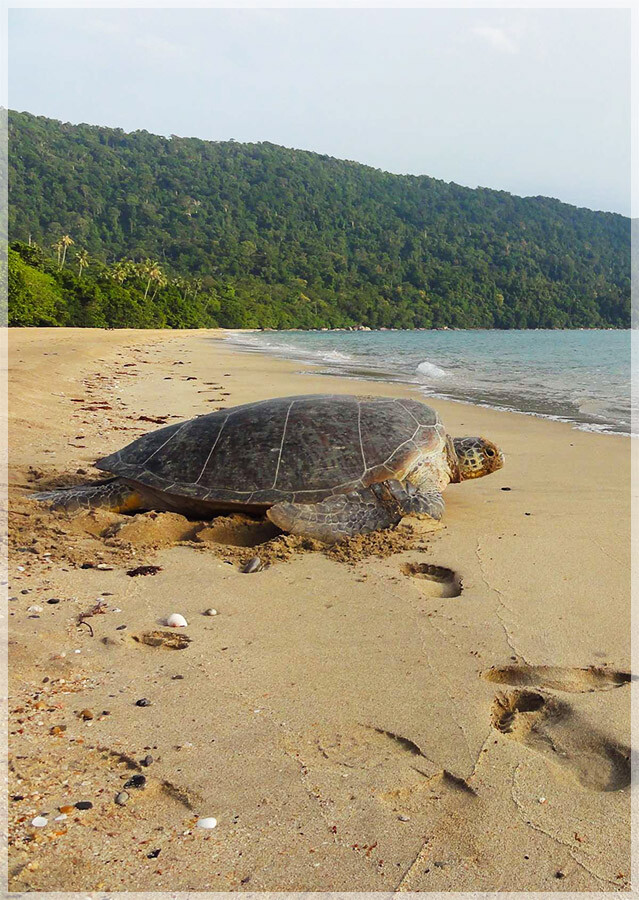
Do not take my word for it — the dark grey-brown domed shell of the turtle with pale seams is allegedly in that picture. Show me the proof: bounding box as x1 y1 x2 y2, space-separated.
96 394 446 506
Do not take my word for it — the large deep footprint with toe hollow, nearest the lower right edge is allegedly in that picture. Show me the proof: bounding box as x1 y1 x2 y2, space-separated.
492 690 630 791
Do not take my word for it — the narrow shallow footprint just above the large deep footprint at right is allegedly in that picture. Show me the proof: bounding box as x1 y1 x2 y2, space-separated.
481 665 631 693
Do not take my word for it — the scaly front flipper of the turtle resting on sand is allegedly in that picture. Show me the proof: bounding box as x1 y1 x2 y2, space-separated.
267 480 444 544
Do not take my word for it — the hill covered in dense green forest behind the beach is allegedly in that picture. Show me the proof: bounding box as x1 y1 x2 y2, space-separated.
9 112 630 328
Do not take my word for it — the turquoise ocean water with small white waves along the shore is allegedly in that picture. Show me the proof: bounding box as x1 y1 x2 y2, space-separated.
228 330 638 434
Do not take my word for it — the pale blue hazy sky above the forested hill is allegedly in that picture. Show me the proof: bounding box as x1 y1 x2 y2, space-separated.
9 8 631 215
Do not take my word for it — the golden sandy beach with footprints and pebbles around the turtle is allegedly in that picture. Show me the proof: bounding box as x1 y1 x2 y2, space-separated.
9 329 630 892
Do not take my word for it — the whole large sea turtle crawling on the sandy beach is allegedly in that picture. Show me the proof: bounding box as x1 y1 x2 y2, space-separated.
35 394 504 543
